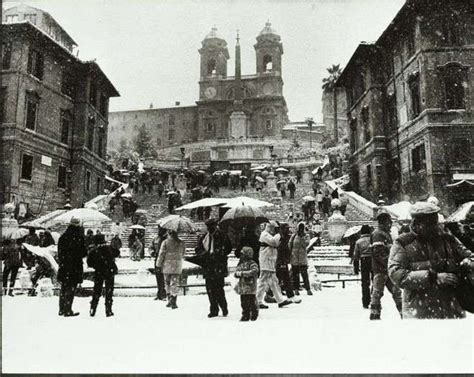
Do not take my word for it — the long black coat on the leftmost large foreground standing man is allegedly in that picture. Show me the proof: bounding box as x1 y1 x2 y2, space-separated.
58 226 87 284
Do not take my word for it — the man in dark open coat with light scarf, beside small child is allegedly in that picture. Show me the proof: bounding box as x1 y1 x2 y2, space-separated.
196 219 232 318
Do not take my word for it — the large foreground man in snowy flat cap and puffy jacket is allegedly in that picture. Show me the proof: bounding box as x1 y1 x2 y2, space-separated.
388 202 474 319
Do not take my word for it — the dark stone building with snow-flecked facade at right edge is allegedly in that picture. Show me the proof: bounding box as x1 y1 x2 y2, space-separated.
338 0 474 206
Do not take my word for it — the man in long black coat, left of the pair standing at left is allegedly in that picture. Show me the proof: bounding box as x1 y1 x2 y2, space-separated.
58 218 87 317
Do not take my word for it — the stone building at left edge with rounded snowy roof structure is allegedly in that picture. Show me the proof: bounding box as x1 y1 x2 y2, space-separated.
0 5 119 215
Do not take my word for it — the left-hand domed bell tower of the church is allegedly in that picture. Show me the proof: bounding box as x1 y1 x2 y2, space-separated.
199 26 229 81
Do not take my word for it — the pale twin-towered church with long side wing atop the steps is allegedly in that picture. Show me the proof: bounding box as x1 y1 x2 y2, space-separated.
109 22 288 163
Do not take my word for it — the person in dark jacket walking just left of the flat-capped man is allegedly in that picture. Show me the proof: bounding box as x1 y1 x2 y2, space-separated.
370 212 402 320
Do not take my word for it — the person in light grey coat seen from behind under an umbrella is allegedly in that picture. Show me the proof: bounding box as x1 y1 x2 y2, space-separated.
156 230 186 309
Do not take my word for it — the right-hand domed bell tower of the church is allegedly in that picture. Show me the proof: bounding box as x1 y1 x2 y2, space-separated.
254 21 283 76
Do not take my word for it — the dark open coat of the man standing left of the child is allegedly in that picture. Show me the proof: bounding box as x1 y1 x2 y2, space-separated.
196 229 232 279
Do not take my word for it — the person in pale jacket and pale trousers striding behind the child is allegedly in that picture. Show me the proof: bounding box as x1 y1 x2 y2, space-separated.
257 220 291 309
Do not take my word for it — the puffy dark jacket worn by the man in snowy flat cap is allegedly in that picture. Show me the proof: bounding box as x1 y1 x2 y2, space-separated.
388 231 474 319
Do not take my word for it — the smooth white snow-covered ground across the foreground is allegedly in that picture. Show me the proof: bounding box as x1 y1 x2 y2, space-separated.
2 283 474 373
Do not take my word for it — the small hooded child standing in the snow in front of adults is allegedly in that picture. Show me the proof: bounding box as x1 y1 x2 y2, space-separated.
234 246 259 321
